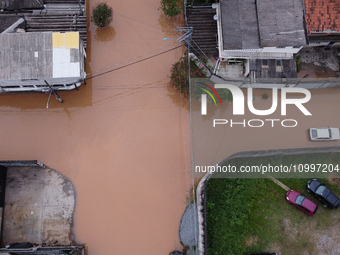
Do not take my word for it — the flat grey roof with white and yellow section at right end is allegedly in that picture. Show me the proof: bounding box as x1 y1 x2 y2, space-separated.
0 32 80 80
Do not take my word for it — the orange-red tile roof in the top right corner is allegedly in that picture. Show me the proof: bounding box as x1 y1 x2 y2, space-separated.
305 0 340 34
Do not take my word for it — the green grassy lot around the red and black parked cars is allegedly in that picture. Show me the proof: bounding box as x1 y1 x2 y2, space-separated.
207 153 340 255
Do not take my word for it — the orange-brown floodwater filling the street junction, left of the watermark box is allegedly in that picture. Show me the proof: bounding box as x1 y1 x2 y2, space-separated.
0 0 192 255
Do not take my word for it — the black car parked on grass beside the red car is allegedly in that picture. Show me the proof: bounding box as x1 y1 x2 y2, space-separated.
307 179 340 209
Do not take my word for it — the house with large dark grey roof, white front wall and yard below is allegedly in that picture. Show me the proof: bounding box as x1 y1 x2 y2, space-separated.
212 0 307 79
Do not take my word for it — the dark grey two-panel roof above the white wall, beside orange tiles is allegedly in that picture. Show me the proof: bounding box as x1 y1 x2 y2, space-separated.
220 0 307 50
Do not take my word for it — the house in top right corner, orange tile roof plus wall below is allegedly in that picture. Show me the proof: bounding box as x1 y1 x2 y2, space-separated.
305 0 340 46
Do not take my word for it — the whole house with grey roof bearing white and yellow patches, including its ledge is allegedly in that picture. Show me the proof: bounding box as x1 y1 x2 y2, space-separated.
0 32 86 92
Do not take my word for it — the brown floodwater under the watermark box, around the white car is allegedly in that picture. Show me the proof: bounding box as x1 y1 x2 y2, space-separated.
192 88 340 170
